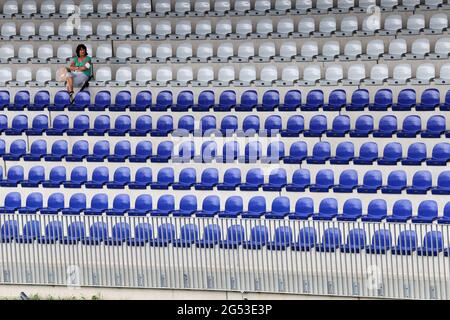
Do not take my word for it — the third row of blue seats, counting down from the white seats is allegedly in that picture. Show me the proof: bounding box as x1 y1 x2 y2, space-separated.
0 139 450 166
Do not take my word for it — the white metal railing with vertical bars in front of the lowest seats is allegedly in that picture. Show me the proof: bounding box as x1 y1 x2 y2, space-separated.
0 214 450 299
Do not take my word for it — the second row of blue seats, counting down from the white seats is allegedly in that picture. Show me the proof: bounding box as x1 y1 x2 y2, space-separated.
0 114 450 138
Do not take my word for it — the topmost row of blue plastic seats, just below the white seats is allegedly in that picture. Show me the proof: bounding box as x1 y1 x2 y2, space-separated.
0 88 450 111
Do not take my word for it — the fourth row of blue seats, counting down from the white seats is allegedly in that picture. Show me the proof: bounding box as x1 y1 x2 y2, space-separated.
0 165 450 195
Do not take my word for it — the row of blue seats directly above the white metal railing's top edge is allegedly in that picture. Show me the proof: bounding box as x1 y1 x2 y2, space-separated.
0 192 450 223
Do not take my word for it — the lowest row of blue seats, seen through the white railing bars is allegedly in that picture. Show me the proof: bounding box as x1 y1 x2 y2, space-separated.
1 220 449 256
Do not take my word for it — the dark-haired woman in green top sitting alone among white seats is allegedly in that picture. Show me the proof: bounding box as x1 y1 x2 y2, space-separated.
67 44 93 98
